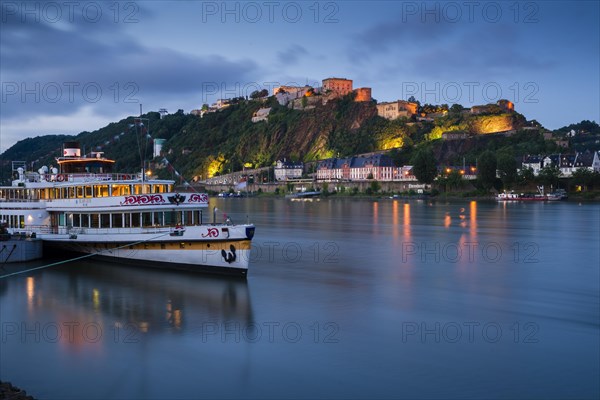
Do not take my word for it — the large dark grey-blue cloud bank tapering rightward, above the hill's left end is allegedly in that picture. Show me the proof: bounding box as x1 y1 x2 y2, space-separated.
0 3 257 118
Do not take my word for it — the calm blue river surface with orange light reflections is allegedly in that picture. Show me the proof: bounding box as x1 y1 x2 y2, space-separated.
0 199 600 399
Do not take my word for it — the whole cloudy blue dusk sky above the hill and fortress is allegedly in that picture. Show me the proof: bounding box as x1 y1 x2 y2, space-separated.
0 0 600 151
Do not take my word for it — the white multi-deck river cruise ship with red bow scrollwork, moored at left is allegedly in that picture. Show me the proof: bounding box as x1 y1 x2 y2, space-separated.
0 143 255 276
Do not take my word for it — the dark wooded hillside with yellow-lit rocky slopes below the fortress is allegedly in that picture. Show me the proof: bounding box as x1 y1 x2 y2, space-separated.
0 95 596 184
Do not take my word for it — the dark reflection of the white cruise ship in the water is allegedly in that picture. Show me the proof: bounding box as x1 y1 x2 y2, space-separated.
6 261 252 344
